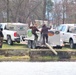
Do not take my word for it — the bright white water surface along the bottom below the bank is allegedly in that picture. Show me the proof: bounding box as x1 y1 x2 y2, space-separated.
0 62 76 75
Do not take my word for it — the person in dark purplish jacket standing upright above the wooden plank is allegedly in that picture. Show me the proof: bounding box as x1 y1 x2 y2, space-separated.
41 24 51 45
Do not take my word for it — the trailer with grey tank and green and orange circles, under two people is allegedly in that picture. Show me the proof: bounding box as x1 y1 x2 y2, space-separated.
25 29 64 49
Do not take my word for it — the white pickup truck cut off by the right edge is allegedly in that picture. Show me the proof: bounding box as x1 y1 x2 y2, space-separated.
57 24 76 48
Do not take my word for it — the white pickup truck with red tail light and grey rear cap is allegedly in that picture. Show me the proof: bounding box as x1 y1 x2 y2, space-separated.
0 23 28 45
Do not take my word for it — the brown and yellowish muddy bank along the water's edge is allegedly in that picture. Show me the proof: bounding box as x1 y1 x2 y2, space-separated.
0 48 76 61
